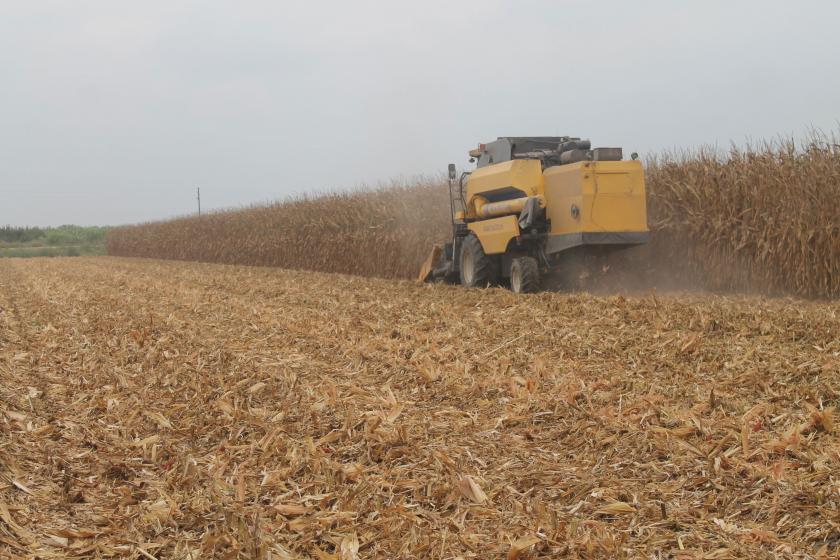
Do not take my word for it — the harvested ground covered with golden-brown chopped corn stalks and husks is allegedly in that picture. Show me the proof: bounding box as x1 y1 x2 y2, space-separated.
0 258 840 560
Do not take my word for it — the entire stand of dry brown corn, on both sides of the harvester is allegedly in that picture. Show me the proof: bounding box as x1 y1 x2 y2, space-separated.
108 135 840 297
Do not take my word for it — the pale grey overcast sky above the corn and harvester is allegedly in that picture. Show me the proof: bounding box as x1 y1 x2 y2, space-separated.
0 0 840 225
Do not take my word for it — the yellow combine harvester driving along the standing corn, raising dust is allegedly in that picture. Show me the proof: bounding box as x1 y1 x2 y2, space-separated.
420 136 650 292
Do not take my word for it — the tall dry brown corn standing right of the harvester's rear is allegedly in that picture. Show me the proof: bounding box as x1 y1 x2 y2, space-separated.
648 137 840 297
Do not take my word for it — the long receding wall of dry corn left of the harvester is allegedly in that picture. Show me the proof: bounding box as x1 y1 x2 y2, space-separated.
108 180 448 278
